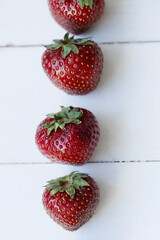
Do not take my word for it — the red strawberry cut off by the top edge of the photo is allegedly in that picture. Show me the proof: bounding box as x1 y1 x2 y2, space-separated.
48 0 105 34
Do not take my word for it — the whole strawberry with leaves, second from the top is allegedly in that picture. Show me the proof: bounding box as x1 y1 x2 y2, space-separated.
42 33 103 95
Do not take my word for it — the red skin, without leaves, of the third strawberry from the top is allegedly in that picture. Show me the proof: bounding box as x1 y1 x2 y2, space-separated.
35 108 100 165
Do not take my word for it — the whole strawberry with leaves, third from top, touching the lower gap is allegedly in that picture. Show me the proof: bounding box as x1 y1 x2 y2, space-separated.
35 107 100 165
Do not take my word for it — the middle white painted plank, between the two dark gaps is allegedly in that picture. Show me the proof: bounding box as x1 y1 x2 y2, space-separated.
0 44 160 162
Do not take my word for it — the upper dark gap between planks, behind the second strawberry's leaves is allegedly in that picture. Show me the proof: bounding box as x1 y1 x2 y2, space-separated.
0 40 160 48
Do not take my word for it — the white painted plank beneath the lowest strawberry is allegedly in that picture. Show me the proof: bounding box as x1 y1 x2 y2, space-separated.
0 163 160 240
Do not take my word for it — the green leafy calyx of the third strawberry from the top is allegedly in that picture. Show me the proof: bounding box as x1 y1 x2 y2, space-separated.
43 106 83 136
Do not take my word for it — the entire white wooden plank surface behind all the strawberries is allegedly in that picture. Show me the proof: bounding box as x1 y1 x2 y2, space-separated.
0 0 160 240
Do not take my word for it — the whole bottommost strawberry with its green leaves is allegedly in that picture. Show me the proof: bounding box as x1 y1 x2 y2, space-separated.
42 172 100 231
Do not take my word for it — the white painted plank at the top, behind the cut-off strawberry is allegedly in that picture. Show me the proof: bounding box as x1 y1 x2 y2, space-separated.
0 0 160 45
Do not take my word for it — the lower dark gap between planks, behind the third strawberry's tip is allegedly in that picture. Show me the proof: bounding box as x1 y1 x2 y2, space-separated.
0 160 160 165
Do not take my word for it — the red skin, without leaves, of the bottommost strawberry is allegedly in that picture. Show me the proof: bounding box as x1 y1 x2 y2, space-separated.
42 176 100 231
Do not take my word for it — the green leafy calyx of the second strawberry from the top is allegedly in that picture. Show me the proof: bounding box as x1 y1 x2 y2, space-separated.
44 33 93 58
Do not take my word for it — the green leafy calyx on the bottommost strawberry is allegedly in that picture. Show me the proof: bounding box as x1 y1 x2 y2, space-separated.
45 171 90 198
